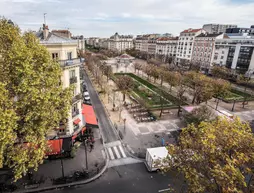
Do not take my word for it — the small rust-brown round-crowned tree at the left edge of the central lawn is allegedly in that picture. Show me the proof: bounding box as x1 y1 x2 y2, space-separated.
116 75 134 101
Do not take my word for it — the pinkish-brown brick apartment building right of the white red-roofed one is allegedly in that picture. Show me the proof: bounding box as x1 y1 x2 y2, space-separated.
191 33 225 69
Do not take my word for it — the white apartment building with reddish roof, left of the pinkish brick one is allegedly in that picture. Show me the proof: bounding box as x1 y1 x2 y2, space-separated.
176 28 205 63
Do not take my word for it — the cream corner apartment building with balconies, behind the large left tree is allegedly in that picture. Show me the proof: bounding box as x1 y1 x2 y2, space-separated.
35 24 85 137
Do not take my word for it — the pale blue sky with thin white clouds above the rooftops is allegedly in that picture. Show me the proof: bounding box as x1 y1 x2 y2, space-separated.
0 0 254 38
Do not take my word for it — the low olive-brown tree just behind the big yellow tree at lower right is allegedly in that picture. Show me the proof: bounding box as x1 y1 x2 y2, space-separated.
184 105 214 125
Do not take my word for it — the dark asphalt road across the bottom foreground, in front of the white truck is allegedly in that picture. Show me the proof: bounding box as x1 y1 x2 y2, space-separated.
45 163 184 193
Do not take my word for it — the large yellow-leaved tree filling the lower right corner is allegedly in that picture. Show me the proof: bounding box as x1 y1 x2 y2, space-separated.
163 118 254 193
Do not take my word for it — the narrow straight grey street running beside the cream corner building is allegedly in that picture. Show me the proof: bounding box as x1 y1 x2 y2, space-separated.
84 68 118 143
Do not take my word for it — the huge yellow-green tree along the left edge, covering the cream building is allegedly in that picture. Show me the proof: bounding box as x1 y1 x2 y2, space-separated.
0 19 72 180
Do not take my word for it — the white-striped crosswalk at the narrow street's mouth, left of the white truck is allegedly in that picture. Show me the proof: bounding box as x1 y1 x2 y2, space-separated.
106 141 127 160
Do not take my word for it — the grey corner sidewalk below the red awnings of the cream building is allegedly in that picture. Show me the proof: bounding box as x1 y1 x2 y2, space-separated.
12 129 108 192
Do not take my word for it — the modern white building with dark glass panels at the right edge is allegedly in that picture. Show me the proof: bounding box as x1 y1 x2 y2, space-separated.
213 36 254 74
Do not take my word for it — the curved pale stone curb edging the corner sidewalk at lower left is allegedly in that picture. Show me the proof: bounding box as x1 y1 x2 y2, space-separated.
15 158 109 193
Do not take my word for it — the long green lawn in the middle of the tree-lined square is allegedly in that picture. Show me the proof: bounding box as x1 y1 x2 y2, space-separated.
115 73 185 107
